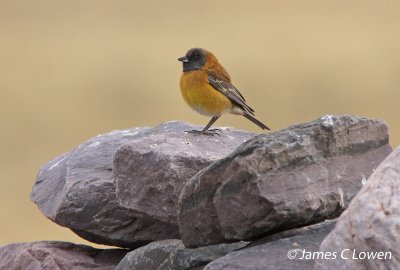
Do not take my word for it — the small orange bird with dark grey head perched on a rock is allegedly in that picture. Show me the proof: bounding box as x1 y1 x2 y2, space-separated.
178 48 269 135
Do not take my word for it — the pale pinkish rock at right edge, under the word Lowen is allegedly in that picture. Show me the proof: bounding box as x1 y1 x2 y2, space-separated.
315 147 400 270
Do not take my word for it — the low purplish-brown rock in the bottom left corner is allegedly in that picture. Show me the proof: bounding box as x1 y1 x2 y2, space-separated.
0 241 127 270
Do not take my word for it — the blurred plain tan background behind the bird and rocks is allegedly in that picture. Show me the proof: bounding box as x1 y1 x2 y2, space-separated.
0 0 400 249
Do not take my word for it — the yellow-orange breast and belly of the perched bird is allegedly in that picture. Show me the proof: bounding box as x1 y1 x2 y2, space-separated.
180 70 232 116
